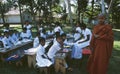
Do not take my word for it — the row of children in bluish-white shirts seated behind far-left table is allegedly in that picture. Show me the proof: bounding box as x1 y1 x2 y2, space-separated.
0 28 32 48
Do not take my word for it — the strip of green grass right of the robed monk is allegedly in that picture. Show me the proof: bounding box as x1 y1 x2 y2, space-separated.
108 29 120 74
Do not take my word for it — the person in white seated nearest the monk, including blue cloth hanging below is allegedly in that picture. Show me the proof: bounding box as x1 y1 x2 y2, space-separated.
72 23 92 59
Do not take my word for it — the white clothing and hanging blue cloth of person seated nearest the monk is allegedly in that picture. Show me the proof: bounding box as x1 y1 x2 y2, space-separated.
72 28 92 59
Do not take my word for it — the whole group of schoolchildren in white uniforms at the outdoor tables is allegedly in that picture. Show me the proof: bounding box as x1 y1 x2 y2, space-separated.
0 21 92 73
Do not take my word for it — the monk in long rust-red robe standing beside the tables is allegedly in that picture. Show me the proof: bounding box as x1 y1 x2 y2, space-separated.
87 14 114 74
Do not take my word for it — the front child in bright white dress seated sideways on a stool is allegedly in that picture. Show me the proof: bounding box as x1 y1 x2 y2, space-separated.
36 37 52 67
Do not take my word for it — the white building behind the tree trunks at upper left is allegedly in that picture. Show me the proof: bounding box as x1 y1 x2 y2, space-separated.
0 9 32 24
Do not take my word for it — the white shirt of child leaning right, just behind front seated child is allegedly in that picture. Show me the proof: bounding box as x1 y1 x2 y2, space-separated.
47 41 61 63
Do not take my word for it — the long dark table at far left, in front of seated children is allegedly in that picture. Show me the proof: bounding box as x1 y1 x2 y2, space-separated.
0 40 33 61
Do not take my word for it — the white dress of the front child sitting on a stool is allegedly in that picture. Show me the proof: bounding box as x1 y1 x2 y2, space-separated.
36 45 52 67
